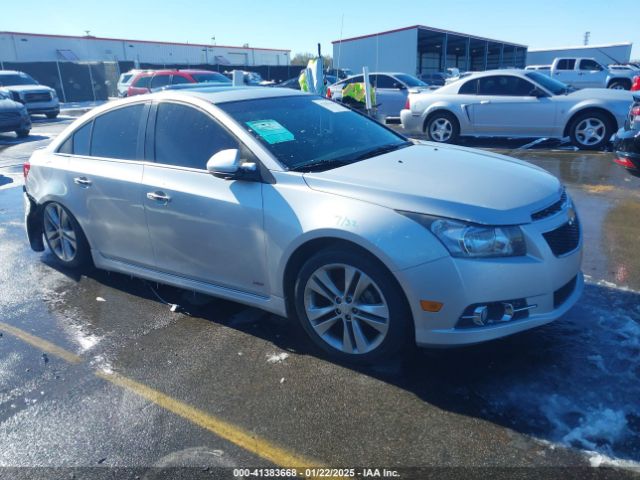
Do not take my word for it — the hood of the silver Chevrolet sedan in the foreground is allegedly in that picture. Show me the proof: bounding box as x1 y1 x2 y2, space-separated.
304 142 562 225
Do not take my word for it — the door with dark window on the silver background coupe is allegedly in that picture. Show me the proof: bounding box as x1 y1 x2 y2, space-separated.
471 75 556 137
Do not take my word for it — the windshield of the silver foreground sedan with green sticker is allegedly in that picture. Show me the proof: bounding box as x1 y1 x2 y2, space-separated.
217 95 411 171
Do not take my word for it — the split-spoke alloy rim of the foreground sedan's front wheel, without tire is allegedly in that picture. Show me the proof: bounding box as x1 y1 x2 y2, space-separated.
304 263 390 354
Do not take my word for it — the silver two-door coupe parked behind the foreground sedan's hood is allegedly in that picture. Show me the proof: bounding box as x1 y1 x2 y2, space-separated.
400 70 632 149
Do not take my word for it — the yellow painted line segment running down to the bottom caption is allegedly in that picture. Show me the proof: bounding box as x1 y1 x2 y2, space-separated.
96 371 320 468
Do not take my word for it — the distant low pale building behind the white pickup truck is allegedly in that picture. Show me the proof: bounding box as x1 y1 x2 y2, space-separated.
527 43 633 65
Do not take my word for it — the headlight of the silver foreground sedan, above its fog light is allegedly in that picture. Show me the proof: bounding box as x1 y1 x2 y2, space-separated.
399 212 527 258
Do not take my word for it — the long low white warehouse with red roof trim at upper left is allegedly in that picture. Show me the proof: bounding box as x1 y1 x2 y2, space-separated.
0 32 290 68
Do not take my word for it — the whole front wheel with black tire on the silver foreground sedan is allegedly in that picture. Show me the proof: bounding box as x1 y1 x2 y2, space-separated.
294 248 412 364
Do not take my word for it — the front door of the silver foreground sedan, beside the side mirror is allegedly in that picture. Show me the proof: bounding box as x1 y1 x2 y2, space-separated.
143 101 267 294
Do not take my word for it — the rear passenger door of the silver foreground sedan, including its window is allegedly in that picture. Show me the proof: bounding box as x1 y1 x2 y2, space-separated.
61 103 153 267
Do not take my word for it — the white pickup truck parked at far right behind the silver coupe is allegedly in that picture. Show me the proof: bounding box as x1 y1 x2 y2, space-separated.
527 57 638 90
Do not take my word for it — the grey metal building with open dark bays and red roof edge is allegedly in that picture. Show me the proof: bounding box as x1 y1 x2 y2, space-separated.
332 25 527 74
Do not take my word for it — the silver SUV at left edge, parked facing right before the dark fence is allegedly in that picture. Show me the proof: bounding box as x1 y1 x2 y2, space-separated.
0 70 60 118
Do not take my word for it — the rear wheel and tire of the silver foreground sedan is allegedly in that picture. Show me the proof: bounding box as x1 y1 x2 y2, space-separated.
42 202 90 270
